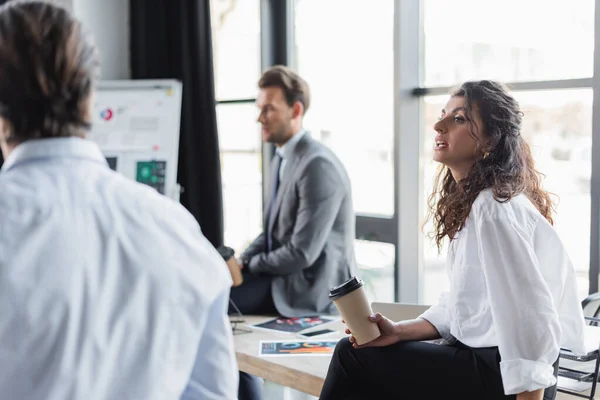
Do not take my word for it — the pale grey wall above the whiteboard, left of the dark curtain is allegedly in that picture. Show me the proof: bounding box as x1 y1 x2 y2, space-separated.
72 0 131 80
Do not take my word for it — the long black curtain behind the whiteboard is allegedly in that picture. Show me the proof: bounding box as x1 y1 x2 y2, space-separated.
130 0 223 247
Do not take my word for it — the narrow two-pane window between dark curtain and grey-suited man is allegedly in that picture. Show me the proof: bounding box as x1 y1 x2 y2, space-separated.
210 0 262 253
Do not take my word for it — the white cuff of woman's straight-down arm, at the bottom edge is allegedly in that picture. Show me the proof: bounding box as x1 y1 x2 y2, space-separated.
500 359 556 395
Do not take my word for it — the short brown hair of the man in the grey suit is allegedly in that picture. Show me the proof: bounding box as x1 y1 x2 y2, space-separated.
258 65 310 113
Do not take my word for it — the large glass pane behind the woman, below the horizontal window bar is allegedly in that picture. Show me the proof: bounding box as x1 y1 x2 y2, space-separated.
422 89 592 303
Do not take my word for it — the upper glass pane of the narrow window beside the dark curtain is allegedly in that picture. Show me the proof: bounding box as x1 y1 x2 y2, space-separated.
210 0 260 100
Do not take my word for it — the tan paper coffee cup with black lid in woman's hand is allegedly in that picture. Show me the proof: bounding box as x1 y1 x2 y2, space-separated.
329 277 381 344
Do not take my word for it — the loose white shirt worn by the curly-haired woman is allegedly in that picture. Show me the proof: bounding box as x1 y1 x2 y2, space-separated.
421 189 585 395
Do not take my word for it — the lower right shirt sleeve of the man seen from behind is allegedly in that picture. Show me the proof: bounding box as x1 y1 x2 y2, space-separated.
181 288 239 400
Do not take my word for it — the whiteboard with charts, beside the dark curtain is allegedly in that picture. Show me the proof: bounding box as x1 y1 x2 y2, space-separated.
89 79 182 201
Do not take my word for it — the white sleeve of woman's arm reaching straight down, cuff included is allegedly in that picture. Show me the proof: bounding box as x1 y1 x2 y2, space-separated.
476 216 561 395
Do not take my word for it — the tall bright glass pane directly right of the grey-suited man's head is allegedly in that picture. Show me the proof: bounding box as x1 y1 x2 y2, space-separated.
294 0 394 216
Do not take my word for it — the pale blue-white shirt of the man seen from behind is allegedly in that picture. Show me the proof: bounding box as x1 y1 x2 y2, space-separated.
0 138 238 400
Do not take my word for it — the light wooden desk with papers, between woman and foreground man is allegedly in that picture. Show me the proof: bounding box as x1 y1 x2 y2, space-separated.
232 316 346 397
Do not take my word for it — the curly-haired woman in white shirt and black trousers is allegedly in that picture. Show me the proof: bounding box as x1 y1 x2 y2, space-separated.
321 81 584 400
